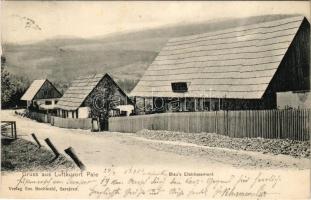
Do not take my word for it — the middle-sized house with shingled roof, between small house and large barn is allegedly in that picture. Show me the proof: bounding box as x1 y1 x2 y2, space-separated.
57 74 131 118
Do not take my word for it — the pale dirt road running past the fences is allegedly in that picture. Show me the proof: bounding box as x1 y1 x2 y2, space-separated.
1 110 309 169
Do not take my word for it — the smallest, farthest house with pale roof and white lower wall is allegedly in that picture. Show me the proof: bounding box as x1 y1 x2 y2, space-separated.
21 79 62 113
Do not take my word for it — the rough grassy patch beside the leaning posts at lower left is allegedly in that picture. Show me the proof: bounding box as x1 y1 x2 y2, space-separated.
1 138 75 171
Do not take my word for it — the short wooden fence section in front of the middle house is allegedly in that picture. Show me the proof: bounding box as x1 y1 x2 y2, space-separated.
51 116 92 130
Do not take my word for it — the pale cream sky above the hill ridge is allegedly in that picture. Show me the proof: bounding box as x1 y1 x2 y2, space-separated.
1 1 310 44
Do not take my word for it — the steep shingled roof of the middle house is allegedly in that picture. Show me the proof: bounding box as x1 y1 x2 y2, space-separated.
56 74 130 110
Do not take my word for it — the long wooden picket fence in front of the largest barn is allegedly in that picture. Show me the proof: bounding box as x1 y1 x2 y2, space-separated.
109 109 311 140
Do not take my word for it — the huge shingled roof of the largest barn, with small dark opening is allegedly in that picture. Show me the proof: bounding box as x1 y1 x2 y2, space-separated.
131 16 304 99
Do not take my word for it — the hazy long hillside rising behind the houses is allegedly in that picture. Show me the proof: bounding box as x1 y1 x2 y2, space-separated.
3 15 300 92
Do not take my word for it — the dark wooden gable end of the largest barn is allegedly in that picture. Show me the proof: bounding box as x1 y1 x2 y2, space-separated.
263 18 310 108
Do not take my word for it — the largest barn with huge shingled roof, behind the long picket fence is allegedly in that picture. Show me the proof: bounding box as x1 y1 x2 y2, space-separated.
131 16 310 113
